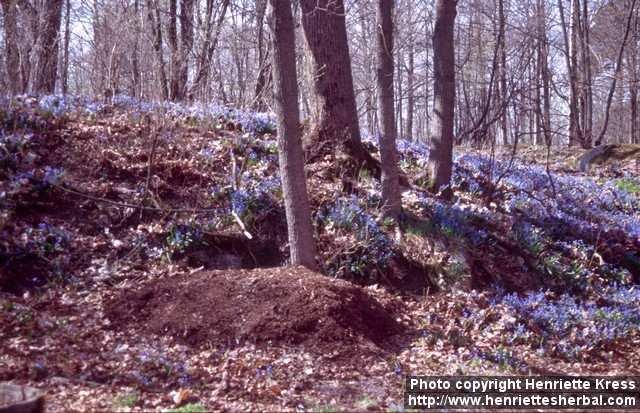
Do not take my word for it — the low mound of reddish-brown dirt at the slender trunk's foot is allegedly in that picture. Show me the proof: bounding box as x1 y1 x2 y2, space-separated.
106 267 402 351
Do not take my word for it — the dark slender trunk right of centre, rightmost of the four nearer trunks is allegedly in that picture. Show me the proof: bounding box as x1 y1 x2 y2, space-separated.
428 0 457 198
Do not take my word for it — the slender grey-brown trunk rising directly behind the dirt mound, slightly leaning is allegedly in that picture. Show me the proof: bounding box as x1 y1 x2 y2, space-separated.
269 0 316 269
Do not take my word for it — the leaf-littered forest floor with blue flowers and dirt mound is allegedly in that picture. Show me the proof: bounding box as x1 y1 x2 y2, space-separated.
0 97 640 411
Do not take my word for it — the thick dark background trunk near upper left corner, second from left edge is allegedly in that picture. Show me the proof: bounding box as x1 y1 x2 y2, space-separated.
29 0 64 93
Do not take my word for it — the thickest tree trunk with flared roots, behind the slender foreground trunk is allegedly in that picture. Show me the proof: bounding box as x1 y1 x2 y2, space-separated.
300 0 380 178
